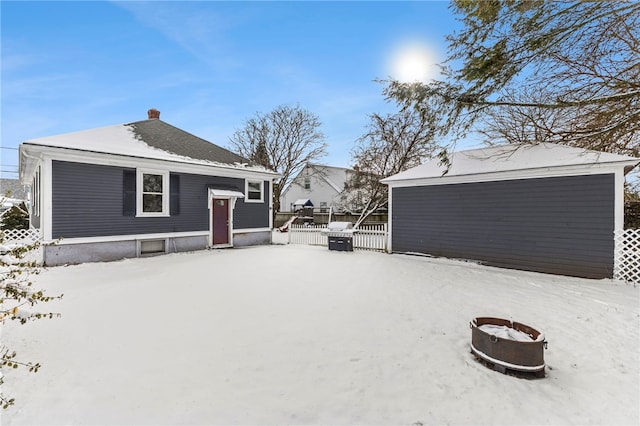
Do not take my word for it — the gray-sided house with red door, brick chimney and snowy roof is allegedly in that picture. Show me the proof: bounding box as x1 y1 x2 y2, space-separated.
20 109 277 265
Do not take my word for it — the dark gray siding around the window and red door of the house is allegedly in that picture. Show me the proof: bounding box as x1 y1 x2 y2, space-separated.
52 161 269 238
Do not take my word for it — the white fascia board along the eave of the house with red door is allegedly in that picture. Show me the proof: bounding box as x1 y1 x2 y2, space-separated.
21 143 280 181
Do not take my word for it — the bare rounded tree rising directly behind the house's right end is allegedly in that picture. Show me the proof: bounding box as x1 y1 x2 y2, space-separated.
230 105 327 217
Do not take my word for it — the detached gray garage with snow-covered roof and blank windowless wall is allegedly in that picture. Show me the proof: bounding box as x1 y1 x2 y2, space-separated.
382 144 640 278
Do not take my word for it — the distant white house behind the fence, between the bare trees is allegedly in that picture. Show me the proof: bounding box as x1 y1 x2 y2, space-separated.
280 164 354 212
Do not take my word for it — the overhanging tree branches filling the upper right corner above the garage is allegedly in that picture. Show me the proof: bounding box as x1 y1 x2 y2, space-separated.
385 0 640 156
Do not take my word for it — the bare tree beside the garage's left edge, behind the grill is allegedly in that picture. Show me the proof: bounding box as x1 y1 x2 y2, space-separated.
342 109 437 228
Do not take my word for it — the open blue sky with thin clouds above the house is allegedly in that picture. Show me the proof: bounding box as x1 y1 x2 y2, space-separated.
0 1 470 177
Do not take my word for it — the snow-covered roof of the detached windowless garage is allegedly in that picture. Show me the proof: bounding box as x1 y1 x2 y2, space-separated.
382 143 640 183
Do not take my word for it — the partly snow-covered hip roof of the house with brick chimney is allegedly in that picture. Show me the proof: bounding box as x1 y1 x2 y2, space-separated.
24 119 276 172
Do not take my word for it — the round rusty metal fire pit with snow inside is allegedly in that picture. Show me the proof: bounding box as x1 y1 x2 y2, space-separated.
470 317 547 377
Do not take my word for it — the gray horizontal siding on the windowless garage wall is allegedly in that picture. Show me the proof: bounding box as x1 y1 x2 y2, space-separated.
392 174 615 278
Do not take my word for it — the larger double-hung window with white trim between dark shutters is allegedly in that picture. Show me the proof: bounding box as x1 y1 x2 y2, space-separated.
136 169 169 216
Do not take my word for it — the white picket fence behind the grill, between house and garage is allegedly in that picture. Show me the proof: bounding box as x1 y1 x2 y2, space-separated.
289 223 387 251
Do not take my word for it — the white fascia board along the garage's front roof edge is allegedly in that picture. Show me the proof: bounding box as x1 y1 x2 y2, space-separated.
381 161 635 188
